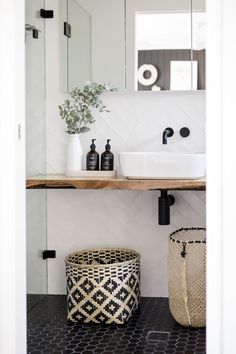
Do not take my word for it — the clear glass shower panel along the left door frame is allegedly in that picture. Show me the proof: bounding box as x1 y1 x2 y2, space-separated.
25 0 47 305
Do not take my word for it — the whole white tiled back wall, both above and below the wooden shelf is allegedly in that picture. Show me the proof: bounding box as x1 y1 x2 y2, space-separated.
43 1 205 296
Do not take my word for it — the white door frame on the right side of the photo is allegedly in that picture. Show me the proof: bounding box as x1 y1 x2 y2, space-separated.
206 0 236 354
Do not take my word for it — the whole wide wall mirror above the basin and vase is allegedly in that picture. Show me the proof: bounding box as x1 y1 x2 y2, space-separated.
62 0 206 91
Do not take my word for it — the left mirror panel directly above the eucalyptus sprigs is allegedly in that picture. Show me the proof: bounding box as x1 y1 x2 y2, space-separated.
64 0 126 91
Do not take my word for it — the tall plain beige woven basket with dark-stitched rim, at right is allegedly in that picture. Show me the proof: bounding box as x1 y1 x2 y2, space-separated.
168 228 206 327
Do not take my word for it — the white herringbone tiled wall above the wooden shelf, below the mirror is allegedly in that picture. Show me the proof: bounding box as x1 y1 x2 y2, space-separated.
47 91 205 173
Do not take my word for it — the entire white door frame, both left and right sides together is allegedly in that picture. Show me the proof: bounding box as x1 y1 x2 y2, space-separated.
0 0 236 354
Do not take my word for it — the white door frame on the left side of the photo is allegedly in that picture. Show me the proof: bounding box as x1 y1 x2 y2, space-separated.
0 0 26 354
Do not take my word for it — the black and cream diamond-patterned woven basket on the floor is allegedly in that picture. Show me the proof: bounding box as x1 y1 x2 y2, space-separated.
65 248 140 324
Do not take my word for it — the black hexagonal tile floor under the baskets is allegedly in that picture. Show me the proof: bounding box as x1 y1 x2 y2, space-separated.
28 295 206 354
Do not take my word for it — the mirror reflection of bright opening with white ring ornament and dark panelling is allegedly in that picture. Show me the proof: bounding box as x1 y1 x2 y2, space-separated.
136 12 205 91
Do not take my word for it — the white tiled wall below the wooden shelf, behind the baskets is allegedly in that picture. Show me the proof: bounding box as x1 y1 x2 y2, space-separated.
48 190 205 296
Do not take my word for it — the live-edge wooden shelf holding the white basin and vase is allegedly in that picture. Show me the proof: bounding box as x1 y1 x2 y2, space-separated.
26 174 206 191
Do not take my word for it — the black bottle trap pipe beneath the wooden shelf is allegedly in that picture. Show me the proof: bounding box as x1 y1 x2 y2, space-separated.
158 190 175 225
